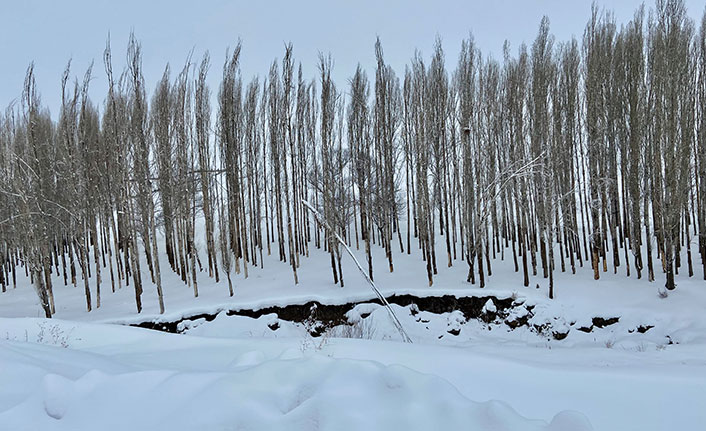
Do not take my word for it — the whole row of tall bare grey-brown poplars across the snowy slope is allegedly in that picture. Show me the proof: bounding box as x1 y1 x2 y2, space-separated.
0 0 706 317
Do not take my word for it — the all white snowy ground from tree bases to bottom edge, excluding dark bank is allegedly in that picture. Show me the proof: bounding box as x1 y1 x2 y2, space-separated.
0 238 706 431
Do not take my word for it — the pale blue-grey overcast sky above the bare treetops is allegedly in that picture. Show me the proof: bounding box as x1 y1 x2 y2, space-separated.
0 0 704 117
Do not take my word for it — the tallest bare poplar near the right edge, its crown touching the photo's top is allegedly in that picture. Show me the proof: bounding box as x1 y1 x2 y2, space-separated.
647 0 695 290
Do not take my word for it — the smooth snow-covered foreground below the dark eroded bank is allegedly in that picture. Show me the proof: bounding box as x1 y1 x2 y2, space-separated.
0 310 706 431
